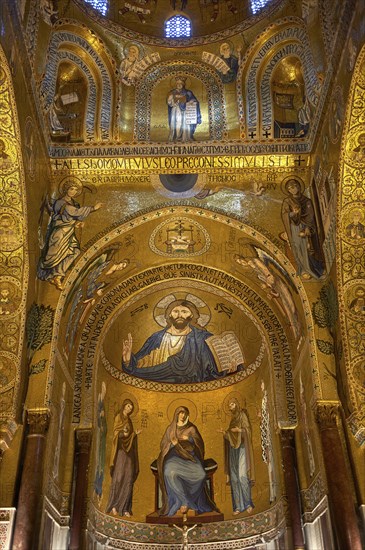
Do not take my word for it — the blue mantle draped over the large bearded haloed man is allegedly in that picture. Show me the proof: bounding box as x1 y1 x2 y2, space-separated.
122 326 225 384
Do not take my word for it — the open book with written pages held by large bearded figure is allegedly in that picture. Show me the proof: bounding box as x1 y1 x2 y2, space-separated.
206 331 245 372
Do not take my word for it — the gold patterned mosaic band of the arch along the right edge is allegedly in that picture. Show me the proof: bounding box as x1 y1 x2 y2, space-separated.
336 42 365 434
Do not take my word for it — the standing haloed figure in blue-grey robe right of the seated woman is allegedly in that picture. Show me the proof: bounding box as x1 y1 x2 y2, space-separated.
220 397 255 515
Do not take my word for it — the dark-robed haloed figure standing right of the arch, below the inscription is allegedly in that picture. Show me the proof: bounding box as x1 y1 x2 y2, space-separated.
281 178 324 280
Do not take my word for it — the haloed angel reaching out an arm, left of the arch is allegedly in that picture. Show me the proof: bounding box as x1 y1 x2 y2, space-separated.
37 179 102 290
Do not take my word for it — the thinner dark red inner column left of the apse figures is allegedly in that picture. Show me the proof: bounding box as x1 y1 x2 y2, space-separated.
69 429 92 550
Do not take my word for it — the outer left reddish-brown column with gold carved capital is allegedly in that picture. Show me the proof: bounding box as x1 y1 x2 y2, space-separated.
12 409 50 550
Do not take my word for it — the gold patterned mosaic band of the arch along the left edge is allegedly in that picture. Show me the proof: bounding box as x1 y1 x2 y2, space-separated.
0 47 29 430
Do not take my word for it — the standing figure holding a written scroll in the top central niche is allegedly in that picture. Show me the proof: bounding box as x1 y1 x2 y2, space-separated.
167 76 202 141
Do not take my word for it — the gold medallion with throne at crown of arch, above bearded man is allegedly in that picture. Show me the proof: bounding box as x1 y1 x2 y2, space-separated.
149 217 210 258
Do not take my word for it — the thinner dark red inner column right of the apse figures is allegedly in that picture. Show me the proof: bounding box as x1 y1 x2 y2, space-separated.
280 428 304 550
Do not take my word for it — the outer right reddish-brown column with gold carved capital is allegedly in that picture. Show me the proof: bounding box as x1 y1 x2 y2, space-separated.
316 401 362 550
